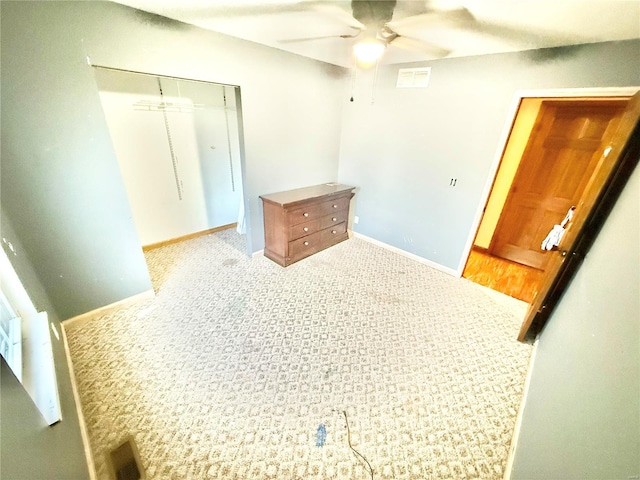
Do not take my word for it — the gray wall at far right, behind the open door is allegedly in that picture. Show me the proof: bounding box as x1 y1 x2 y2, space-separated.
511 164 640 480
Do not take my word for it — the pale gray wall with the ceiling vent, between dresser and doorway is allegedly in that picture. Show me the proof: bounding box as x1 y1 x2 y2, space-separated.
338 40 640 270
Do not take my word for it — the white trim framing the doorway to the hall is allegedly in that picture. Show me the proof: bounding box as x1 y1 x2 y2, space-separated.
456 86 640 277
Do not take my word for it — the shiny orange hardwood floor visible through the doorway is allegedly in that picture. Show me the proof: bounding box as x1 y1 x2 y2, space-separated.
462 248 544 303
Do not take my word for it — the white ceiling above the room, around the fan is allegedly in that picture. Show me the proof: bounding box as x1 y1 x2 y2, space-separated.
112 0 640 67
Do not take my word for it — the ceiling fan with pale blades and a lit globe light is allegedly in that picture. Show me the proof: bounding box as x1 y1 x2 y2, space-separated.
280 0 475 64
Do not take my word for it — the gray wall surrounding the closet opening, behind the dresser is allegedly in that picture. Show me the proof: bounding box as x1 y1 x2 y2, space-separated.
1 2 344 319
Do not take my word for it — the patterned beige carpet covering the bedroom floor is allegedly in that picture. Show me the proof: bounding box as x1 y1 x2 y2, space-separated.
66 230 531 480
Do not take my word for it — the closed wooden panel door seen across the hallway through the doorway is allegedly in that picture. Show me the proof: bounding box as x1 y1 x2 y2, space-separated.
489 99 627 270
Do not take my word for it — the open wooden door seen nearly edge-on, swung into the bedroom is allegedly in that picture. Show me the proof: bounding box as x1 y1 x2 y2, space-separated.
518 91 640 341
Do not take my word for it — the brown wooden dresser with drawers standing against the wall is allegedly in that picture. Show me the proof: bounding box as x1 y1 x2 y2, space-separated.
260 183 355 267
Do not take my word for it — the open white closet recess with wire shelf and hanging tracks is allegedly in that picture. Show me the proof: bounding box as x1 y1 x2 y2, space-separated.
94 66 250 286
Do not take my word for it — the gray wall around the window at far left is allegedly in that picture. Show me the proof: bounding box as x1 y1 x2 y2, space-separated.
0 212 89 480
